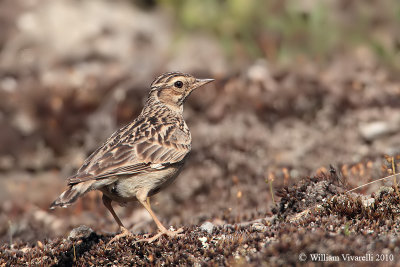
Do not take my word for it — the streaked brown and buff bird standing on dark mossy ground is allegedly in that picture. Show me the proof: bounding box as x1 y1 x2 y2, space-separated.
50 72 214 244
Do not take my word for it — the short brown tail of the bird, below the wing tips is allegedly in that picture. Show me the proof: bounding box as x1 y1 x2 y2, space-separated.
50 181 96 209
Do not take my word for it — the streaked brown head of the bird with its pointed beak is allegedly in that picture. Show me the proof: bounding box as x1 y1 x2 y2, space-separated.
150 72 214 111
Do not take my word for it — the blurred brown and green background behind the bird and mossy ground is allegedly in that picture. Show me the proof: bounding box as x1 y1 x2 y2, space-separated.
0 0 400 243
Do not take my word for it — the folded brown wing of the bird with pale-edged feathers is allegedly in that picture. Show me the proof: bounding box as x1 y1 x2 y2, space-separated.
68 121 191 185
